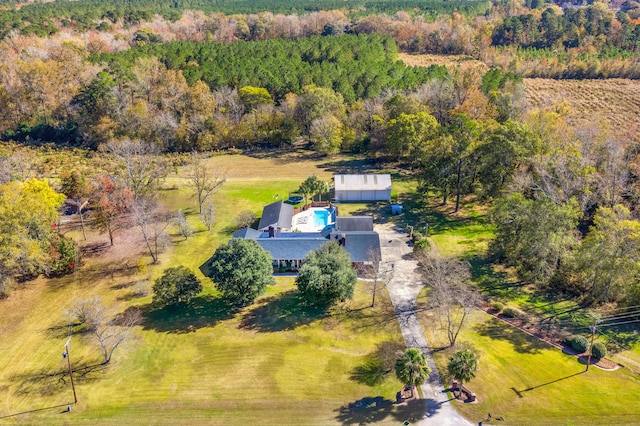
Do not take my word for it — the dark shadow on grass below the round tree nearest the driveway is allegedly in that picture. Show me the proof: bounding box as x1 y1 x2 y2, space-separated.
240 290 326 332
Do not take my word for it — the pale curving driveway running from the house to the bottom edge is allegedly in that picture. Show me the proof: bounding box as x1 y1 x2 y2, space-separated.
375 223 472 426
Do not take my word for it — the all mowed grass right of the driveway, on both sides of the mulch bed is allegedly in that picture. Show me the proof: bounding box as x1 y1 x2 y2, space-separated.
418 200 640 425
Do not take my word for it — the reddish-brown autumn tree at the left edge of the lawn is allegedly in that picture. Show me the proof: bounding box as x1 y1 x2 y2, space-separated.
91 176 133 245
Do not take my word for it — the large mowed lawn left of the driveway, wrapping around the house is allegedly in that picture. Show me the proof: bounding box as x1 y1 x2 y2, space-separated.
0 154 409 425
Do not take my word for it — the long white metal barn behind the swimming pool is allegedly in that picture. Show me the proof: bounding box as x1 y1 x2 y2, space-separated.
334 175 391 202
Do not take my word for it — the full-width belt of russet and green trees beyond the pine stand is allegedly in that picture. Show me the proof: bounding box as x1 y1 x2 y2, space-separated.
0 1 640 78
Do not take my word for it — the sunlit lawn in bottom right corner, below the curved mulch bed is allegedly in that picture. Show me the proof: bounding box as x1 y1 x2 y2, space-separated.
421 311 640 425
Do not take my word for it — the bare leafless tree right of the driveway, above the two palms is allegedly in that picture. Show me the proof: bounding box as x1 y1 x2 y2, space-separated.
418 250 480 346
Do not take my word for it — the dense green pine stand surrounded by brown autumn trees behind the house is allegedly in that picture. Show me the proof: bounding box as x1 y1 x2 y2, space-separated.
96 35 446 103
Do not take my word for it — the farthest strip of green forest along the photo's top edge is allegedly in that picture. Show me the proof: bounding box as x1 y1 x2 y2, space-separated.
0 0 489 38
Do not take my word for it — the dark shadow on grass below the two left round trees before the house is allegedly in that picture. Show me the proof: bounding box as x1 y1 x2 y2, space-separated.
142 295 235 333
